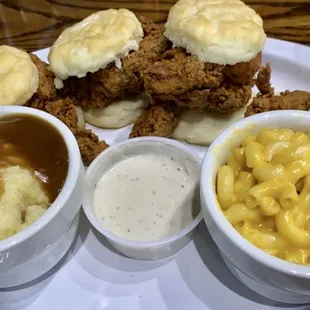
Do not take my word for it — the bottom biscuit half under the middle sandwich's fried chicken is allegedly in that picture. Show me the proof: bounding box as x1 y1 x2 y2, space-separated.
84 95 148 128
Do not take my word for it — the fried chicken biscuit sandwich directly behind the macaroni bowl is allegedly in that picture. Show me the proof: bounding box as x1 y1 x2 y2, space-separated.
131 0 266 145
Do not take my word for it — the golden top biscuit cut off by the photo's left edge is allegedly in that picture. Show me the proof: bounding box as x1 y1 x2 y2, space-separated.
0 45 39 106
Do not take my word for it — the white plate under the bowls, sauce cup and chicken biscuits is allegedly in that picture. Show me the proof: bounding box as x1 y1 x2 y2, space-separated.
0 39 310 310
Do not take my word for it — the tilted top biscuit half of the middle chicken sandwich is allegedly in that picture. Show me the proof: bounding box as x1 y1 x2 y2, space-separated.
48 9 143 80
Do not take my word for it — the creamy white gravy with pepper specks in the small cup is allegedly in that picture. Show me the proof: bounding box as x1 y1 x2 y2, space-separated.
94 153 200 241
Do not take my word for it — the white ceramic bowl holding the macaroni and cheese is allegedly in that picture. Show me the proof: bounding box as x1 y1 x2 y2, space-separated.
200 110 310 304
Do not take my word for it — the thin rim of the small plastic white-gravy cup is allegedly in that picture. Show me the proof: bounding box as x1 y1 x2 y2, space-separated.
82 137 203 249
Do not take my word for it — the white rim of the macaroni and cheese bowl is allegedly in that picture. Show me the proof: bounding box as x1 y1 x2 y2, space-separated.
200 110 310 278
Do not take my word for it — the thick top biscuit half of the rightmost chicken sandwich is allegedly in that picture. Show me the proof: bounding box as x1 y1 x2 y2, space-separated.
164 0 266 65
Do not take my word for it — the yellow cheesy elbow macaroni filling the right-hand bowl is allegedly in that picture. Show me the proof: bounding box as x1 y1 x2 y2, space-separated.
216 129 310 265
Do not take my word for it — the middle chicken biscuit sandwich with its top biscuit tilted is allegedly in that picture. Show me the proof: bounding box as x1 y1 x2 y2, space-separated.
49 9 167 128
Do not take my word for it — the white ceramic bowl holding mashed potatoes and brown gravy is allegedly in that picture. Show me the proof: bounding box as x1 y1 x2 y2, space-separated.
0 106 85 288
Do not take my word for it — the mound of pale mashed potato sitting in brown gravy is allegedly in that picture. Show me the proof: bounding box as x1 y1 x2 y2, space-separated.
0 166 49 240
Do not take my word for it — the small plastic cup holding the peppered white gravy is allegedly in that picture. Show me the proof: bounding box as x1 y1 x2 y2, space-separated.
83 137 202 260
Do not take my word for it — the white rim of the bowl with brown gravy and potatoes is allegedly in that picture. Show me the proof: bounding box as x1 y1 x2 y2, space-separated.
0 106 81 251
